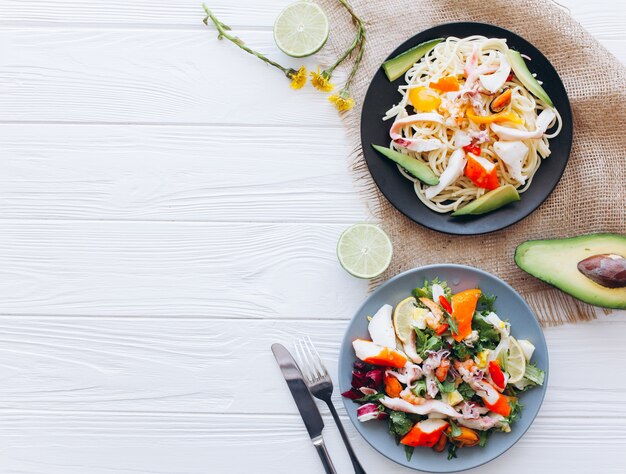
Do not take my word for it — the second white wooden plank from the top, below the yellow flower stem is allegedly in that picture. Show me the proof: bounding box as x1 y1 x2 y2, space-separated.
0 28 340 126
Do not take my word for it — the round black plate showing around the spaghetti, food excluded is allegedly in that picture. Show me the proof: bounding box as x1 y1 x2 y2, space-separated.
361 22 572 235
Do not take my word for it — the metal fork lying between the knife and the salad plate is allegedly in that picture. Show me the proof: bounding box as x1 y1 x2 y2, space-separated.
295 337 366 474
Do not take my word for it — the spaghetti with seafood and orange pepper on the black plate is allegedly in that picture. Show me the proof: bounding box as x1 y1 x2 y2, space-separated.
383 36 561 213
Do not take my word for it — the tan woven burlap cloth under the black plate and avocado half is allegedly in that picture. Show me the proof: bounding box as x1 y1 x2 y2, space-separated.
319 0 626 325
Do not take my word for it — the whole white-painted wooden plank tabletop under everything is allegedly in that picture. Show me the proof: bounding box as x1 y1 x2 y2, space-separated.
0 0 626 474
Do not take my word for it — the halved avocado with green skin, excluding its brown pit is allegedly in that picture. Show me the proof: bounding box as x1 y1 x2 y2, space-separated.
515 234 626 309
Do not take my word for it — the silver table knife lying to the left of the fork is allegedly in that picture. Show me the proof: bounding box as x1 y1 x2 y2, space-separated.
272 343 337 474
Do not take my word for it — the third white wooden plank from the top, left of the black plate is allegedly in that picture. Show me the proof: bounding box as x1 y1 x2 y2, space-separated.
0 125 366 223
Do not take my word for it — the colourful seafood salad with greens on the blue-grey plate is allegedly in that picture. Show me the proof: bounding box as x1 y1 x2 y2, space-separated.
342 279 544 460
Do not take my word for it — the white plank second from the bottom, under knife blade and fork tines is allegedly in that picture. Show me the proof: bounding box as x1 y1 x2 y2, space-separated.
0 314 626 414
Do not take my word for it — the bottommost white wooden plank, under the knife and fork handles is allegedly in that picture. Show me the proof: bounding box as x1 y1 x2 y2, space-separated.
0 412 626 474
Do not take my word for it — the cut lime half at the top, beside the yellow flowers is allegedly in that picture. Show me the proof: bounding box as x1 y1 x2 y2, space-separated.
274 1 330 58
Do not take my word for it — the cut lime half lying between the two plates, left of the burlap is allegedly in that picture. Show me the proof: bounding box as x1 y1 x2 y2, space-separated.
337 224 393 278
